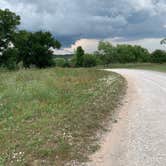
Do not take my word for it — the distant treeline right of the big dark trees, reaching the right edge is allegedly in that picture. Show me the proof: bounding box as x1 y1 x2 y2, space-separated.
55 41 166 67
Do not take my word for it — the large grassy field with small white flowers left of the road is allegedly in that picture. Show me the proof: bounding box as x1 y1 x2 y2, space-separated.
0 68 125 166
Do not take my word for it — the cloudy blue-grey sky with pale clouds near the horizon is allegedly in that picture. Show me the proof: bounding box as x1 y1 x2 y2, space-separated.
0 0 166 53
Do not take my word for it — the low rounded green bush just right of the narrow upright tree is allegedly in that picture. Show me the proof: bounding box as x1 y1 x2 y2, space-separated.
83 54 97 67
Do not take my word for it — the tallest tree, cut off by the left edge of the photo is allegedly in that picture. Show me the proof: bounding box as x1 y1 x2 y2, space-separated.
0 9 20 65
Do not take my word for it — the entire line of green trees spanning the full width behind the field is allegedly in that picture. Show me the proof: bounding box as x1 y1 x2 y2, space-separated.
0 9 166 69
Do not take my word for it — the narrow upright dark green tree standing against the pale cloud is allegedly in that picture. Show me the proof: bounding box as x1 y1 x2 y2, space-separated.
75 46 84 67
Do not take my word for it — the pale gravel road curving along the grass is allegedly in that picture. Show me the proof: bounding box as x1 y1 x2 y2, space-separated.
88 69 166 166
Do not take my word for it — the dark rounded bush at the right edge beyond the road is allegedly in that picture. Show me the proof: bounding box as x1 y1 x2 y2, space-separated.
151 50 166 63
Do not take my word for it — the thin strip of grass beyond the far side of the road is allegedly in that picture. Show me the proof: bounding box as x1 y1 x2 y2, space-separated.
109 63 166 72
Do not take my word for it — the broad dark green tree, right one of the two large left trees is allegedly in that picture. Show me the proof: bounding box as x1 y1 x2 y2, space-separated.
14 31 61 68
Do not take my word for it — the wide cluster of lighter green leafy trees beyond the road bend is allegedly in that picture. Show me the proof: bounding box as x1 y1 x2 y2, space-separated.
98 41 150 65
